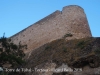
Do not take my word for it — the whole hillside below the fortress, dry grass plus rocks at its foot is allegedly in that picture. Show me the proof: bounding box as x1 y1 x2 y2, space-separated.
24 37 100 75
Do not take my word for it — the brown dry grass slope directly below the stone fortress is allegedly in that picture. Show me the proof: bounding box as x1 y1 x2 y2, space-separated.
26 38 100 68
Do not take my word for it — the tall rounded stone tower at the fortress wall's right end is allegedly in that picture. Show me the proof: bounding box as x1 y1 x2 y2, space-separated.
62 5 92 39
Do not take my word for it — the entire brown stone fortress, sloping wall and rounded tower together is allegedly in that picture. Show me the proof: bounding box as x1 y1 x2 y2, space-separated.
11 5 92 53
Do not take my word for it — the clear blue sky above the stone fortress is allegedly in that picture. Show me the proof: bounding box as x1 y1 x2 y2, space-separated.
0 0 100 37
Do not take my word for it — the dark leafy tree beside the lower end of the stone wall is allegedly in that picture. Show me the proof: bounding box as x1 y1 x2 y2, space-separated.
0 36 27 67
